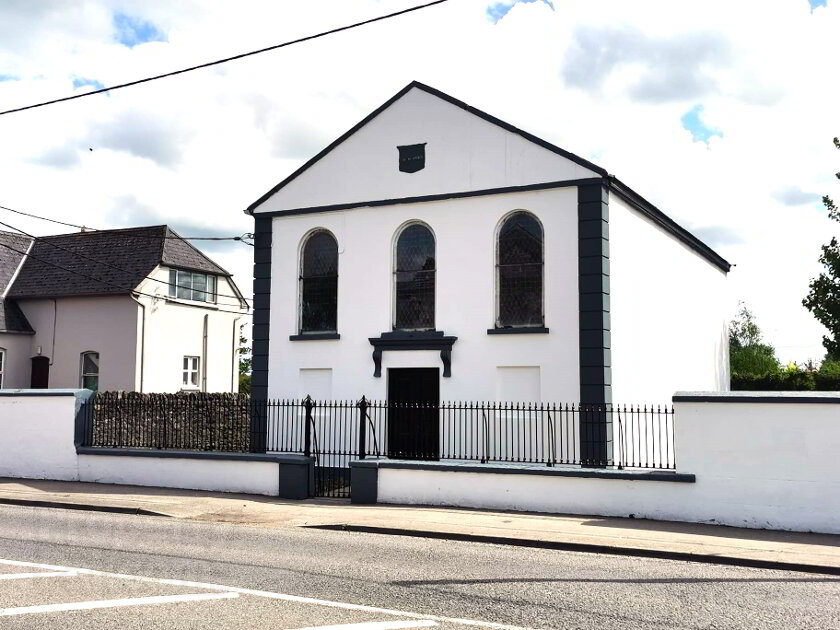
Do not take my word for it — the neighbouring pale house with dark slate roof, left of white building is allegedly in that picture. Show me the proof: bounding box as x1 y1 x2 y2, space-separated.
0 225 248 392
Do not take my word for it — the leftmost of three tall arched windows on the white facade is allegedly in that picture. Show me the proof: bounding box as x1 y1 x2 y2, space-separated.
300 230 338 334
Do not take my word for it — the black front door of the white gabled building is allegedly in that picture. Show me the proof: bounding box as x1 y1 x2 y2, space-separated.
388 368 440 459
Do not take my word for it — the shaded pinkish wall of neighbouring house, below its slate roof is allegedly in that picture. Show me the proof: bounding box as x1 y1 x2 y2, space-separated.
18 296 138 391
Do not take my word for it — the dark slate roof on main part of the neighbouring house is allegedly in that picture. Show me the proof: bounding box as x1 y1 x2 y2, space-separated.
7 225 230 298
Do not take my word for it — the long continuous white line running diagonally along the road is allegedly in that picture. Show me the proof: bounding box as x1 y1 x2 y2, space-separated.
0 559 536 630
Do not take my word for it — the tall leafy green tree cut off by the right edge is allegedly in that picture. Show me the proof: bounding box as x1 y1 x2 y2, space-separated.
802 138 840 361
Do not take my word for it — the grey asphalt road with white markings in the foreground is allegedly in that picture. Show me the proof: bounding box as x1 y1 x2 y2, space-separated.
0 506 840 630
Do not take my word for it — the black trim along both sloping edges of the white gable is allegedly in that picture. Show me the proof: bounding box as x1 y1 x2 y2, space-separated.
245 81 607 214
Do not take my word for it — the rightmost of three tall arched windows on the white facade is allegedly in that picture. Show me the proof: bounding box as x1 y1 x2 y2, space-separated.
496 212 545 328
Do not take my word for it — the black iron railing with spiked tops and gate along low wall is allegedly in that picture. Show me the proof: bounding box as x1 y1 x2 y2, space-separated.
82 393 675 474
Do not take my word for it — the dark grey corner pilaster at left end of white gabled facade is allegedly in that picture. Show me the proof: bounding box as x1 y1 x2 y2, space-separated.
251 215 272 452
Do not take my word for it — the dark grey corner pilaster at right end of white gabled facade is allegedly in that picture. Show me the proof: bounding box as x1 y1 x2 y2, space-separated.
578 181 612 466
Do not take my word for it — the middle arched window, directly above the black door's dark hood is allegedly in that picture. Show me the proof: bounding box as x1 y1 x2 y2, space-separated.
394 223 435 330
